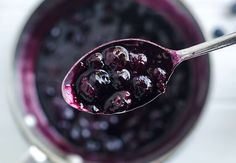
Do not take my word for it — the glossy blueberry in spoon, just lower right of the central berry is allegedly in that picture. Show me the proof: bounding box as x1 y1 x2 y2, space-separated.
132 76 153 100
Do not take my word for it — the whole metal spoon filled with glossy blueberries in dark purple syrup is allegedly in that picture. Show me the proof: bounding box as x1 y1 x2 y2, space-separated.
62 33 236 114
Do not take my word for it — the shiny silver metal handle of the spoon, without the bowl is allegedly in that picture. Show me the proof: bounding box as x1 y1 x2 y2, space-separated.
176 32 236 61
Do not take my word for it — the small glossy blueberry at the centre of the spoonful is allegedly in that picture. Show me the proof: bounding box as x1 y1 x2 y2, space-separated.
112 69 130 90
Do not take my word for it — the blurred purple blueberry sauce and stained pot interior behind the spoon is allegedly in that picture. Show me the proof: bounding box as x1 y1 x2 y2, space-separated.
15 0 209 162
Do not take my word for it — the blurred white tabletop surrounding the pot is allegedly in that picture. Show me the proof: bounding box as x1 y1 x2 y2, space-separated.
0 0 236 163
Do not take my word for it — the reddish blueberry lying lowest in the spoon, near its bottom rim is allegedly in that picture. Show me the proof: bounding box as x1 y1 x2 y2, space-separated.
104 91 131 113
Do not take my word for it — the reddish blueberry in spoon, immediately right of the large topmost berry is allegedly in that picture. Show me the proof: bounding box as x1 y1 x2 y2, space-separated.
130 53 147 72
